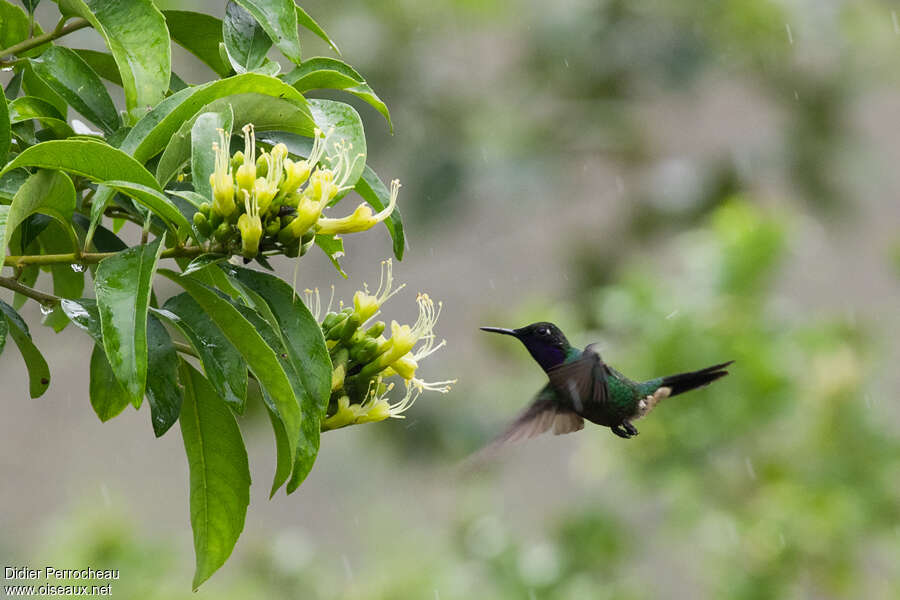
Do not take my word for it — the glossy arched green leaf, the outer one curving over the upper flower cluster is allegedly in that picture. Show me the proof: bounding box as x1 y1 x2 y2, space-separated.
120 73 316 163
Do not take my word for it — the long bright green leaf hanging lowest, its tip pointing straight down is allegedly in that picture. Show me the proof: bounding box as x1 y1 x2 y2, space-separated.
179 361 250 591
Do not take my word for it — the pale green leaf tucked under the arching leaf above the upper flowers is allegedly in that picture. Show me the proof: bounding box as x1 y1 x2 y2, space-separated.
156 94 307 185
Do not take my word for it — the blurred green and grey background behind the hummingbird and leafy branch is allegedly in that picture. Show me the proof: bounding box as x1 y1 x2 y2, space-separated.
0 0 900 600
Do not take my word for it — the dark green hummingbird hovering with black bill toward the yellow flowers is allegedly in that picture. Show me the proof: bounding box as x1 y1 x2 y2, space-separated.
481 322 734 445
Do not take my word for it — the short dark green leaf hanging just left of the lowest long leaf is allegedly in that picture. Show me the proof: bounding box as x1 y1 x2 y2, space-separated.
147 314 183 437
